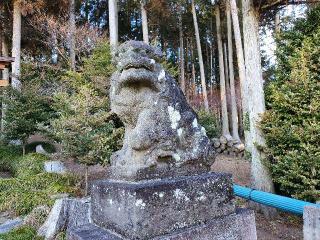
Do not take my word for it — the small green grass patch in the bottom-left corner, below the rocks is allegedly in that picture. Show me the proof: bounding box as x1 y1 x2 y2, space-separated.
0 226 44 240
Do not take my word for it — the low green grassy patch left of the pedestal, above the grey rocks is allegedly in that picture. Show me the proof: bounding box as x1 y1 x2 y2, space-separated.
0 143 81 215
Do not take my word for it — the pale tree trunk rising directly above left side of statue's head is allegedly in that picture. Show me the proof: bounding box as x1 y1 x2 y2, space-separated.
108 0 118 47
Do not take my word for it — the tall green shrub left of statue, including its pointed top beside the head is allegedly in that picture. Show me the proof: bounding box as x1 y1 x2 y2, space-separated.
47 43 124 165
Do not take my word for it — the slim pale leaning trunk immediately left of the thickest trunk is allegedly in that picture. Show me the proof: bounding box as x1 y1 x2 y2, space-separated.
230 0 253 149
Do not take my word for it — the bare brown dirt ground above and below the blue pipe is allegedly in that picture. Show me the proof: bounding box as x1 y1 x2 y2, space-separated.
212 155 303 240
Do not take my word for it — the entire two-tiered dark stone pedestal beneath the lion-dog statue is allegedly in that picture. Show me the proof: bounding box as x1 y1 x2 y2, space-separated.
68 173 256 240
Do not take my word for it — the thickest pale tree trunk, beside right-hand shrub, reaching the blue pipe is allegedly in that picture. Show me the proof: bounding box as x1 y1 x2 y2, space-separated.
242 0 274 206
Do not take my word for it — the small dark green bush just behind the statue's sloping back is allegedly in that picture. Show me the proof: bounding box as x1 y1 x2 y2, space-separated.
198 110 221 139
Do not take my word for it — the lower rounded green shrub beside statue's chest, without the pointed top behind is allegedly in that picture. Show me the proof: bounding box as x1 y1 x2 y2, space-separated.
50 85 123 165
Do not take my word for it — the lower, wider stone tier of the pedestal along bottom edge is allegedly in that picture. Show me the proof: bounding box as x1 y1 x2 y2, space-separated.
68 209 257 240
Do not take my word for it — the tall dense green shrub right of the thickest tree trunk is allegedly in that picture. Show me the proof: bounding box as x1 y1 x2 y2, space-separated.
261 8 320 201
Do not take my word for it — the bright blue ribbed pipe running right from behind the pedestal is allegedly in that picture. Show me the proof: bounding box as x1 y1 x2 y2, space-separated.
233 185 320 215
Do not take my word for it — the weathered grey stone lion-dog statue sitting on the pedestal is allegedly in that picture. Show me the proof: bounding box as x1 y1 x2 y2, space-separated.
110 41 214 180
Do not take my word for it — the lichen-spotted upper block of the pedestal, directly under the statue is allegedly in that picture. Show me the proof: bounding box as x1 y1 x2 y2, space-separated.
91 173 235 239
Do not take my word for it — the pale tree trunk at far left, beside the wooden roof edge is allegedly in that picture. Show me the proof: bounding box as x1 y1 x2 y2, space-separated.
11 0 21 90
